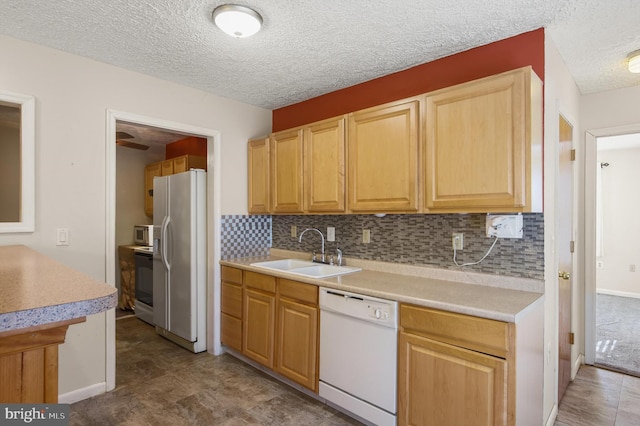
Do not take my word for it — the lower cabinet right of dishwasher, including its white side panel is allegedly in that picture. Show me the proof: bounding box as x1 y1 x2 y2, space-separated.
398 298 544 426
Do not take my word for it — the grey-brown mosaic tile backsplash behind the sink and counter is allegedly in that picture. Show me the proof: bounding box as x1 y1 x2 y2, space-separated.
222 213 544 280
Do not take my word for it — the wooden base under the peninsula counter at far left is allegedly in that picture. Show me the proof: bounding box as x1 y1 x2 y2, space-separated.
0 317 85 404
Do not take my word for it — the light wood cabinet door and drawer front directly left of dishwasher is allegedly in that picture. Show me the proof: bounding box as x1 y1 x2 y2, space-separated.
276 279 320 392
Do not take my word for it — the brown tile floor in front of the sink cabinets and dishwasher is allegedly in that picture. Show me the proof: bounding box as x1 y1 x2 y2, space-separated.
70 317 361 426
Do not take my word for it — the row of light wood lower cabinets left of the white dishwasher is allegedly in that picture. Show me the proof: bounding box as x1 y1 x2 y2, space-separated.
220 266 320 392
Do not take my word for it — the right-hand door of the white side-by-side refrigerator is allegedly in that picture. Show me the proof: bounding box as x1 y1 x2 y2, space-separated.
165 172 197 342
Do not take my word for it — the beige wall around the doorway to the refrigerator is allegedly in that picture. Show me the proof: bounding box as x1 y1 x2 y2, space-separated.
0 36 271 394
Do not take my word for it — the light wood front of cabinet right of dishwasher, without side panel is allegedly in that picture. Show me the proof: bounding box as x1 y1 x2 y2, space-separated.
398 304 514 426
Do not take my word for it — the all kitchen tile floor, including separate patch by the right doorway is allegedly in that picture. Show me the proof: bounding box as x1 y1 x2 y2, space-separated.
70 316 640 426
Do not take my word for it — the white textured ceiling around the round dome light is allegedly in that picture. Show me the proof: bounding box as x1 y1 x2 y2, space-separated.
0 0 640 109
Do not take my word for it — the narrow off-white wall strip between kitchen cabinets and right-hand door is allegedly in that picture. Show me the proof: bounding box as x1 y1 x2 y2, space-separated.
544 33 580 420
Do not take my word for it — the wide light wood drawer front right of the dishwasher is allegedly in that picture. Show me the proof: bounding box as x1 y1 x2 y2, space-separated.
400 305 514 358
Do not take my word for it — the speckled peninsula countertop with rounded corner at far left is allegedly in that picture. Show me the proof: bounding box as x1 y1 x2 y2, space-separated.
0 245 118 332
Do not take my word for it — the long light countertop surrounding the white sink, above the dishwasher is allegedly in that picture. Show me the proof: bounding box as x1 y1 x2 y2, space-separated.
220 250 544 322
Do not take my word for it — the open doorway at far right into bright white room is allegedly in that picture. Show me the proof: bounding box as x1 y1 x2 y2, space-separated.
594 133 640 376
